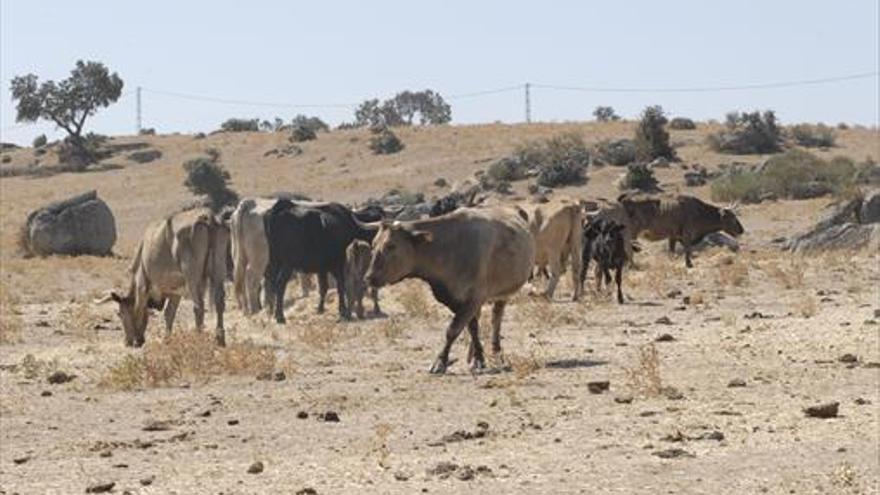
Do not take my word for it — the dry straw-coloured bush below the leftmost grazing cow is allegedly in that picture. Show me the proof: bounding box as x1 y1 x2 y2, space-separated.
101 332 276 390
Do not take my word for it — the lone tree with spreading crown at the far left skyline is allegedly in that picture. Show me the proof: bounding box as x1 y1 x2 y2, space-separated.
10 60 123 162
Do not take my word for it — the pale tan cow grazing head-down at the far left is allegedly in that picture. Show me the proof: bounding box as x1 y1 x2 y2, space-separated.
100 208 229 347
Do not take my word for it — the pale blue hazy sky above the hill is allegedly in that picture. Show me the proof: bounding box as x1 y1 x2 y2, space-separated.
0 0 880 144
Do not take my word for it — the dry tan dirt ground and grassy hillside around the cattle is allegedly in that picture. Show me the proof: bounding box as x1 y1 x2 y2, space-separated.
0 124 880 494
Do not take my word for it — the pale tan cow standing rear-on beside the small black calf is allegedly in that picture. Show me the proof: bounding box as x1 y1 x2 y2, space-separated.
528 199 583 301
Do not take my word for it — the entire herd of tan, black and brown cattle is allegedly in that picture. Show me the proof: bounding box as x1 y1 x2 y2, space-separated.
96 193 743 373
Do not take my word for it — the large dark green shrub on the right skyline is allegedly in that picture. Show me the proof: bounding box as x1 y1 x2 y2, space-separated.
708 110 782 155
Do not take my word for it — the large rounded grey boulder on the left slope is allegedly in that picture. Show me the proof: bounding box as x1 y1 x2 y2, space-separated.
23 191 116 256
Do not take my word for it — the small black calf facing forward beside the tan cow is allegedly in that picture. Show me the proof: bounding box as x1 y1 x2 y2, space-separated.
580 218 627 304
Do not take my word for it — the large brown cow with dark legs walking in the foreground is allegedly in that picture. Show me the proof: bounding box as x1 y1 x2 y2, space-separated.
367 208 535 374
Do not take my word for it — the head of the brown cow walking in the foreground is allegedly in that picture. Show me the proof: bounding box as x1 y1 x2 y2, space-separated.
366 222 433 287
